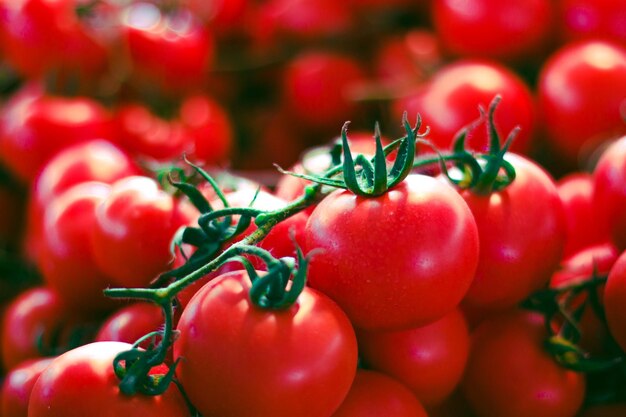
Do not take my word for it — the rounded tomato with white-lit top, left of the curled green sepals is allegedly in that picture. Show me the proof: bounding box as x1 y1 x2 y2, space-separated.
91 176 188 287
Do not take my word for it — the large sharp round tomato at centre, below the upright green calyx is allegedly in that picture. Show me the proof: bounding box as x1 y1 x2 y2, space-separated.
305 175 478 330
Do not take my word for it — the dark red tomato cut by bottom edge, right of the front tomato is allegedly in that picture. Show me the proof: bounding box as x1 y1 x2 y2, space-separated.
332 370 427 417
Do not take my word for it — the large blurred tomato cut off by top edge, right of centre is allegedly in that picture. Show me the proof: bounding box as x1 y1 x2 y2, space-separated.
432 0 555 62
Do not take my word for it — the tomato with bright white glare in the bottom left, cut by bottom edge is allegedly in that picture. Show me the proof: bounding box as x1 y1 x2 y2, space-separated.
28 342 190 417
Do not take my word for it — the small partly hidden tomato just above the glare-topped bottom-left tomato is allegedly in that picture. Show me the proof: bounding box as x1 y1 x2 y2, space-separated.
95 302 165 347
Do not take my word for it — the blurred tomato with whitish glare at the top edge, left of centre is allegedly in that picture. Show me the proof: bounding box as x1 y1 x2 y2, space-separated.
122 2 215 92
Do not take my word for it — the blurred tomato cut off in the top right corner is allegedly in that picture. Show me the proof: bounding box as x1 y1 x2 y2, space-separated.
557 0 626 45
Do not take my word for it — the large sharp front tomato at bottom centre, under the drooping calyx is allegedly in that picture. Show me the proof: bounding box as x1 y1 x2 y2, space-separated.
174 271 357 417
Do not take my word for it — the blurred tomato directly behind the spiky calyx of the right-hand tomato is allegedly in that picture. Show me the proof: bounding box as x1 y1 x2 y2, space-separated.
392 60 535 154
